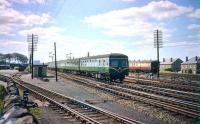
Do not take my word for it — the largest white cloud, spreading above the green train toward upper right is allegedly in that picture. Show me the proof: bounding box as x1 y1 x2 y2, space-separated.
84 1 193 36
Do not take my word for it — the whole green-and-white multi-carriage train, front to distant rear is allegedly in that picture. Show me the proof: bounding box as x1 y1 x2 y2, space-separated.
48 53 129 81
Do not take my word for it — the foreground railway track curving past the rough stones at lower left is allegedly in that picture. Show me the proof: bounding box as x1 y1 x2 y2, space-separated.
7 75 142 124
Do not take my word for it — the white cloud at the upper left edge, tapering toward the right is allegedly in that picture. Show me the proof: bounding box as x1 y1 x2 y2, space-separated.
0 1 51 35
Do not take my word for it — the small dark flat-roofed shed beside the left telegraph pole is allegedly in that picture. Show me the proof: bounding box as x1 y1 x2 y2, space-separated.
33 64 48 77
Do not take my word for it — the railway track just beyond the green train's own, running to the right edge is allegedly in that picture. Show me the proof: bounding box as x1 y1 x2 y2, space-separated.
124 78 200 93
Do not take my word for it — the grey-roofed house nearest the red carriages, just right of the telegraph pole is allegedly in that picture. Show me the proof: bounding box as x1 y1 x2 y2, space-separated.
160 58 183 72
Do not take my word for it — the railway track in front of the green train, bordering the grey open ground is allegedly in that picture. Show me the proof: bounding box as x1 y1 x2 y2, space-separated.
52 73 200 118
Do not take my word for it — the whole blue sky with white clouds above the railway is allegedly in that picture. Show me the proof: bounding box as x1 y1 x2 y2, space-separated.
0 0 200 62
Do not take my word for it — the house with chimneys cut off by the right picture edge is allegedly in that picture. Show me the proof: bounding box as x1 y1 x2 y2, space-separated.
181 56 200 74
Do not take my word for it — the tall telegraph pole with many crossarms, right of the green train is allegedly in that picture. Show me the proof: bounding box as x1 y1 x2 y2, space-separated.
154 29 163 78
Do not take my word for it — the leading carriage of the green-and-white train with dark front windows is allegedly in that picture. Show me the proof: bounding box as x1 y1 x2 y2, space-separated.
80 54 128 81
